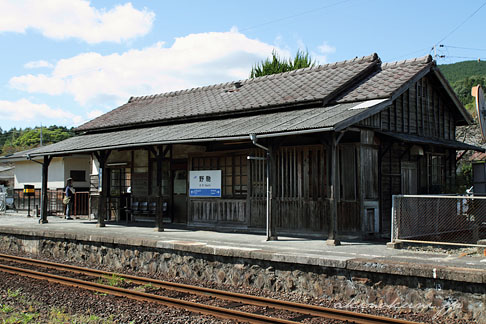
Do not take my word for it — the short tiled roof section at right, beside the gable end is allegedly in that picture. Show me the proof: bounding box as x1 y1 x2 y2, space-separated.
336 55 432 102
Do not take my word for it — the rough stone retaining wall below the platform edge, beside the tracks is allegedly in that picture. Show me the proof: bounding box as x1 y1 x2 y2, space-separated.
0 235 486 324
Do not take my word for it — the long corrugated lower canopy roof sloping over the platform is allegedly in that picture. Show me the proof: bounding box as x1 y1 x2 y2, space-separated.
30 101 374 156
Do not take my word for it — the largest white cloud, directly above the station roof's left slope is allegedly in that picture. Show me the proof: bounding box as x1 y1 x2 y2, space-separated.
10 29 289 107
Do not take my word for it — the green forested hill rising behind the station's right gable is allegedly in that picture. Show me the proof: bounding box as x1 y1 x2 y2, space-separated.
439 61 486 115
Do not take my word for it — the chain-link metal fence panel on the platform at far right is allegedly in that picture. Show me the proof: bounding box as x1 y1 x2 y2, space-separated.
391 195 486 246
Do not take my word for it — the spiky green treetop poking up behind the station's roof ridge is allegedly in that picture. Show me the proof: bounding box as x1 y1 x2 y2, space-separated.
250 50 316 78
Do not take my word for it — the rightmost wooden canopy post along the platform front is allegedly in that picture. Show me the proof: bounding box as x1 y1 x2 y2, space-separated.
326 133 342 245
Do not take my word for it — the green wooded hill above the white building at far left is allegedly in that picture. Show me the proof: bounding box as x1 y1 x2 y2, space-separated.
0 126 74 155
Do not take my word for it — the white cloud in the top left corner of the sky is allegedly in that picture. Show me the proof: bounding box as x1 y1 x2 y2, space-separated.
0 0 155 43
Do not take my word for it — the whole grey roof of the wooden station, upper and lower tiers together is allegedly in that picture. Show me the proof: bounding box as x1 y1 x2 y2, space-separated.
21 54 476 156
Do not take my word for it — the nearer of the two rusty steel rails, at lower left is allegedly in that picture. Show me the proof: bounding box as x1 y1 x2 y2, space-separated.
0 264 298 324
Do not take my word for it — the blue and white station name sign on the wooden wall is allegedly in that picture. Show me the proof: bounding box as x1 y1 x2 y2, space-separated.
189 170 221 197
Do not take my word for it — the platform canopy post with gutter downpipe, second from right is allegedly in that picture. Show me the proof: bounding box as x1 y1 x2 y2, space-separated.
267 143 278 241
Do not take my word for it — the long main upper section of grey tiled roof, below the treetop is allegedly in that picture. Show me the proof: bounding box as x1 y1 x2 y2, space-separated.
77 54 380 131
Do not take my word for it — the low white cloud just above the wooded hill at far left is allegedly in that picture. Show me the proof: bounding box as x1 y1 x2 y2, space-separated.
0 99 83 125
